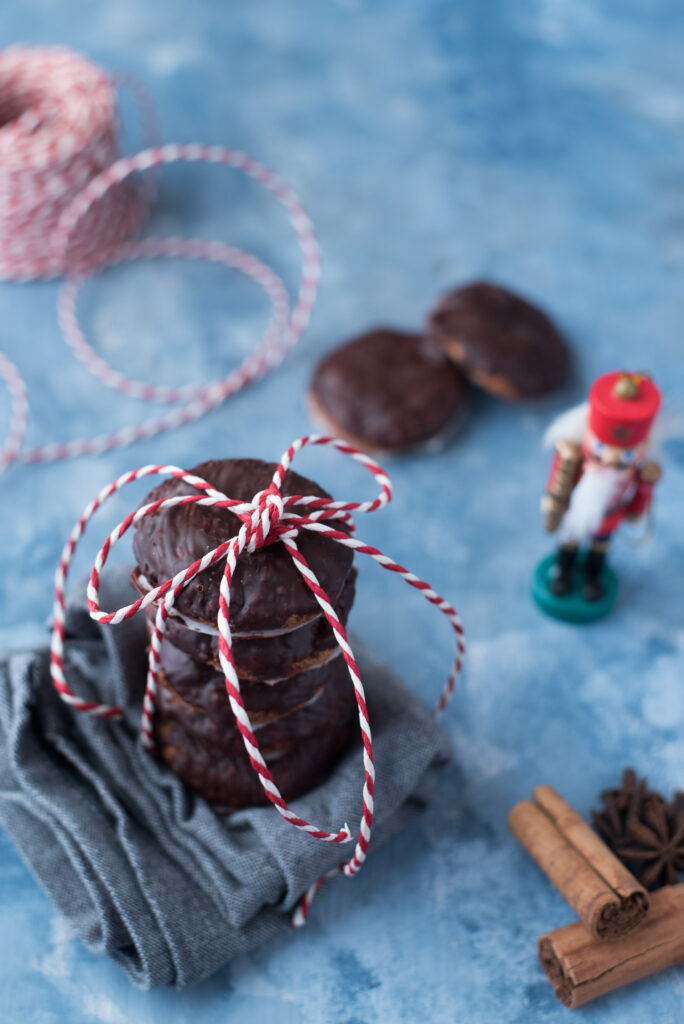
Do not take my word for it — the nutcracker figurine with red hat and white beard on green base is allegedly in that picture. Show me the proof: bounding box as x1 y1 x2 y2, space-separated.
532 372 660 623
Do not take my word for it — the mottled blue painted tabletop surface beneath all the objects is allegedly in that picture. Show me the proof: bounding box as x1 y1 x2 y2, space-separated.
0 0 684 1024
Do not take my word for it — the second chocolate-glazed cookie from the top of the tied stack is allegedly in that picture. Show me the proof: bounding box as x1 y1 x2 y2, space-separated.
146 568 356 680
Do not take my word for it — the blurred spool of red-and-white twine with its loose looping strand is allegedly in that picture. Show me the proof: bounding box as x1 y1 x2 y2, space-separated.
0 46 320 471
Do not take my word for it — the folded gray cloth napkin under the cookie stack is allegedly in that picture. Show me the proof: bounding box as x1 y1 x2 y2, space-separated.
0 571 450 988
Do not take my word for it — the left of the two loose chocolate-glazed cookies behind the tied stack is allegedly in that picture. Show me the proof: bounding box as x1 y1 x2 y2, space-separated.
309 328 468 453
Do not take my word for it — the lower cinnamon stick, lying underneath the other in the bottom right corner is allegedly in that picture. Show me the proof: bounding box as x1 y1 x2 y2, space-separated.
539 883 684 1010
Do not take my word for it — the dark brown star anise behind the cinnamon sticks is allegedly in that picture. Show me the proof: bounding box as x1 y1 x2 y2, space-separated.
593 768 684 889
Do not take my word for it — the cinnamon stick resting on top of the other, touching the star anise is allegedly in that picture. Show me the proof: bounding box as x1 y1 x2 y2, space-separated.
508 785 649 940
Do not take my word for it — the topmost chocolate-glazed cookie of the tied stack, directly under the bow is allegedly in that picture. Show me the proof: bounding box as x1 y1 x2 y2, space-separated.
132 459 352 633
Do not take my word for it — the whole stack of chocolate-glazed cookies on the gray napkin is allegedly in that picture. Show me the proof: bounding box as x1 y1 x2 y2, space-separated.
132 459 356 812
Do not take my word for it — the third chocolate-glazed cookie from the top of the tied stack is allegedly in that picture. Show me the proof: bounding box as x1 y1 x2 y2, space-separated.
157 657 355 755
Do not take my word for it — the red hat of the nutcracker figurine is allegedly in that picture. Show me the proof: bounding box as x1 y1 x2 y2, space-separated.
589 371 660 449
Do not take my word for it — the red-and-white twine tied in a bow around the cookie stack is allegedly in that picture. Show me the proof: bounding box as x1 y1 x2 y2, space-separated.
50 435 465 927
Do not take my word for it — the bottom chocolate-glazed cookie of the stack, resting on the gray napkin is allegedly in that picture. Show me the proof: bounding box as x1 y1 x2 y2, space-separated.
155 675 355 813
